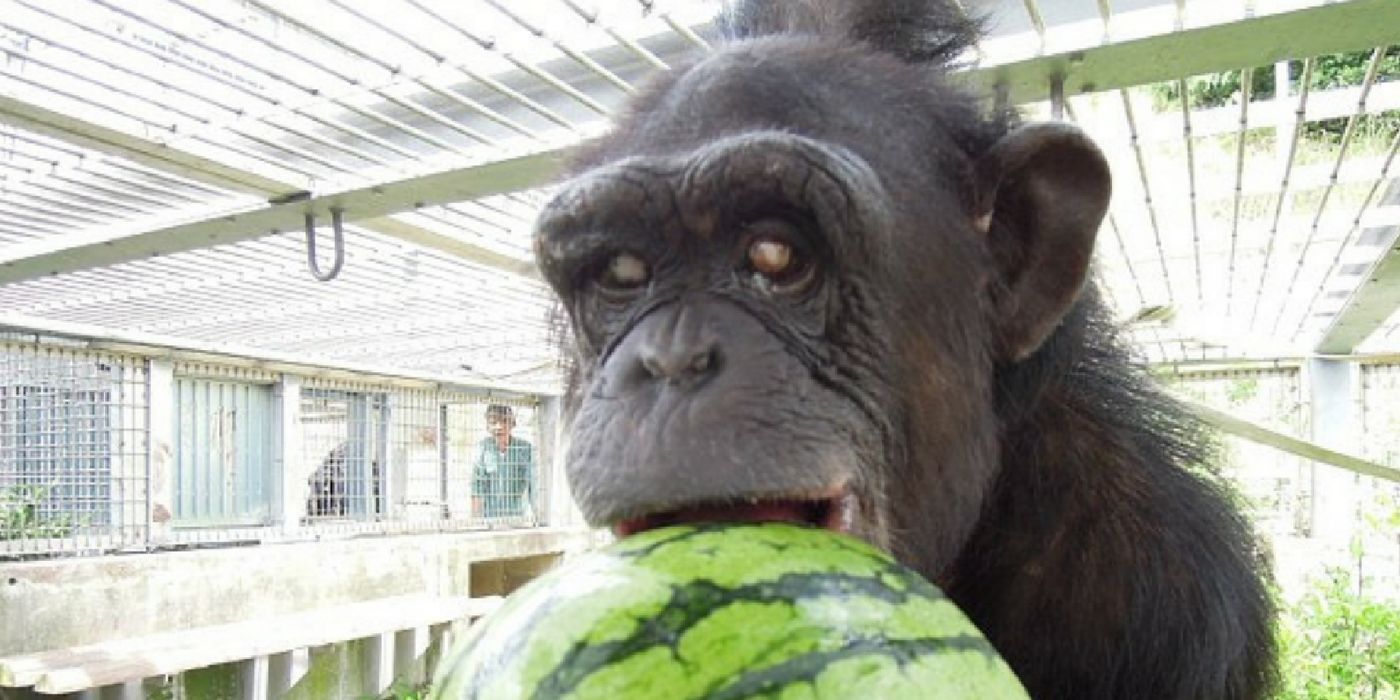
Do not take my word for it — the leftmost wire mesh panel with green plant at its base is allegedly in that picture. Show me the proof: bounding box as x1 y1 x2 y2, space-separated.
0 343 150 556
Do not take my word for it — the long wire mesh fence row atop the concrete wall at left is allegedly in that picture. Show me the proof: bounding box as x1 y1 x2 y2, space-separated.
0 340 547 560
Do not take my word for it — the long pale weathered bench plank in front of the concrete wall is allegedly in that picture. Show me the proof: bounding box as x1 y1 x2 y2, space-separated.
0 595 501 694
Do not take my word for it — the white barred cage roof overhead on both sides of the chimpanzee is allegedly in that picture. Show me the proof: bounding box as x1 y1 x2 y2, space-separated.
0 0 1400 389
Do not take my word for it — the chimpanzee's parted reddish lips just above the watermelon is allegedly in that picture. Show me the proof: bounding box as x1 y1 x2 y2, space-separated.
613 487 857 538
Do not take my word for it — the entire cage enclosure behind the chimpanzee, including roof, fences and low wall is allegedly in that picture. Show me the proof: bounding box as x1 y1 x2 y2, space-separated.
0 0 1400 697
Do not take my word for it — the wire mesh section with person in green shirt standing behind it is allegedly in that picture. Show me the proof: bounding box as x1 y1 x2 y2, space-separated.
301 385 543 529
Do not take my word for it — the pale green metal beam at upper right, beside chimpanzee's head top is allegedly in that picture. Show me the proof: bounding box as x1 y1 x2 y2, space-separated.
960 0 1400 104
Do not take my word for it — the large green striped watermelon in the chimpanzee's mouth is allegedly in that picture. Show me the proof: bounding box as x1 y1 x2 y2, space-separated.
430 522 1026 700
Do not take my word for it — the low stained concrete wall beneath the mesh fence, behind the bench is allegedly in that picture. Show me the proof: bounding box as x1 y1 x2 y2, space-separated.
0 528 598 655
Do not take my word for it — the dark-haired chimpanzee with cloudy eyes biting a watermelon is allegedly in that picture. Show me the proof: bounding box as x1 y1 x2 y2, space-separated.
535 0 1274 700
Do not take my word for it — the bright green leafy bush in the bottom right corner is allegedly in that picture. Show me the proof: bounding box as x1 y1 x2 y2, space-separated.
1278 568 1400 700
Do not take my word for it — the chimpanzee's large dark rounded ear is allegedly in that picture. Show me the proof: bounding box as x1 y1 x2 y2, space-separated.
974 122 1112 363
